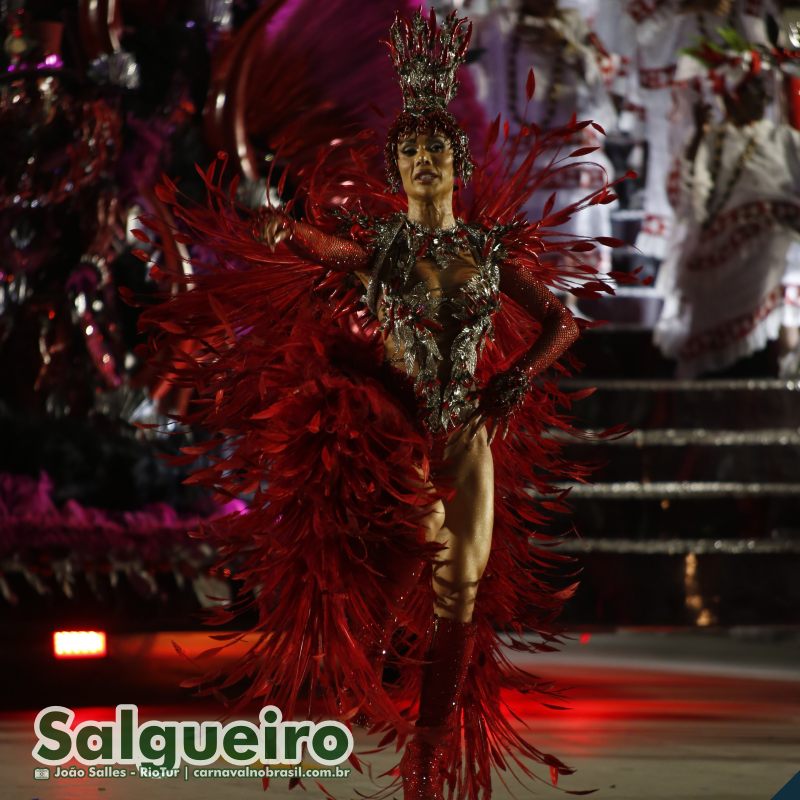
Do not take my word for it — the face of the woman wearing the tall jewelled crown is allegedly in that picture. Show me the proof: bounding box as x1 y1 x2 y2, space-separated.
397 131 453 201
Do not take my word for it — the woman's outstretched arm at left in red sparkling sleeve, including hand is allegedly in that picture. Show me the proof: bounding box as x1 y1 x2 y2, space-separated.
253 212 369 272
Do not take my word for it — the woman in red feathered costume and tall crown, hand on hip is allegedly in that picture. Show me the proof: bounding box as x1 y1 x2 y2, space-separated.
140 6 613 800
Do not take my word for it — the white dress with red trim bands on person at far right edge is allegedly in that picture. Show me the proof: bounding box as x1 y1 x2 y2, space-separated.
653 120 800 377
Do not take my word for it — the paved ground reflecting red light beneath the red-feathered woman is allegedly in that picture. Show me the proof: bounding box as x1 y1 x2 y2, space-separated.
0 631 800 800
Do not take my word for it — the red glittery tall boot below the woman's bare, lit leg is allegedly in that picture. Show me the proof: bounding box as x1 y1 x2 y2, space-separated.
400 615 475 800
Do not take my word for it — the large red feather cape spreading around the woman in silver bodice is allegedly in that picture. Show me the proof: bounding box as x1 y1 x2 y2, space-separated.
137 114 632 800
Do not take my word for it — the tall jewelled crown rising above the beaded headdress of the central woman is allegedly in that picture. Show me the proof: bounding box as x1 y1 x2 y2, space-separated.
386 9 472 114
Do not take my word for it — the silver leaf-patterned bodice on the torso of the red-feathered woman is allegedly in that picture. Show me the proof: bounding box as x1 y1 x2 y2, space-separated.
367 215 503 434
